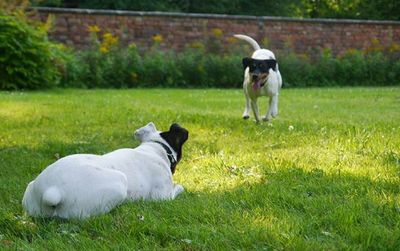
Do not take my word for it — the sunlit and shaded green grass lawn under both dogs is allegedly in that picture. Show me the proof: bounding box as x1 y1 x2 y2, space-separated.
0 88 400 250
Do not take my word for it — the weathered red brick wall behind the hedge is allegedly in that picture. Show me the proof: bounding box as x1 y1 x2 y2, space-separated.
37 8 400 54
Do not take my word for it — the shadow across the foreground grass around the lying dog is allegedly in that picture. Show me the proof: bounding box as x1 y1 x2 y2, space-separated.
0 142 400 250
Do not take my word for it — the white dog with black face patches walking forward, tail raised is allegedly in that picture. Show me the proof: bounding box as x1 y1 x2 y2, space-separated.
234 35 282 122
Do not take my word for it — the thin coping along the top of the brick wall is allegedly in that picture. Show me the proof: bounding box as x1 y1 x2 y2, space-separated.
32 7 400 26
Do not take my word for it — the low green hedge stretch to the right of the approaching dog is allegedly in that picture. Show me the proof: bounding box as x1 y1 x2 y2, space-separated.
278 50 400 87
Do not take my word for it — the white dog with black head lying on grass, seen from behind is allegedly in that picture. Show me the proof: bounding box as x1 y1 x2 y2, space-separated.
22 123 189 218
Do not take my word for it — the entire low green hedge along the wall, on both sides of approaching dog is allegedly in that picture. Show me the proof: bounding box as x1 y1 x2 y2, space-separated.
63 46 400 88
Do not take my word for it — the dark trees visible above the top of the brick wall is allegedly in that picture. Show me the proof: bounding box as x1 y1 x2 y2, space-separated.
34 0 400 20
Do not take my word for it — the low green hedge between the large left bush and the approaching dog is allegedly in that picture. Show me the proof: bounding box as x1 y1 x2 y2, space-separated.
61 46 243 88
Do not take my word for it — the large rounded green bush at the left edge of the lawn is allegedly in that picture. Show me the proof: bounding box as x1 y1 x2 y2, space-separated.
0 13 62 90
